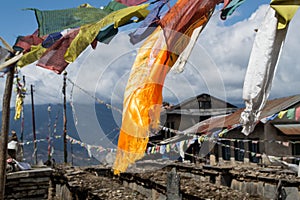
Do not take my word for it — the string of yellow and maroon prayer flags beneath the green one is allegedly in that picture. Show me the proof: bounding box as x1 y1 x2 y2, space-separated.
15 5 149 74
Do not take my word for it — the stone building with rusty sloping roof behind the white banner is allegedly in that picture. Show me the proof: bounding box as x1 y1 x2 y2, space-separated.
185 95 300 164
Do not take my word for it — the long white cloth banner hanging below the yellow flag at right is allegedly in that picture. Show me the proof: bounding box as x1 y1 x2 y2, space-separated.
240 7 288 135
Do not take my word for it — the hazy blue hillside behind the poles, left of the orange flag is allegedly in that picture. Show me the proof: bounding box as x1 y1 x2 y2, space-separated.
0 104 121 166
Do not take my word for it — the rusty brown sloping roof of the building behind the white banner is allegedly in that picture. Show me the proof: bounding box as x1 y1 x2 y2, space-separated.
184 95 300 133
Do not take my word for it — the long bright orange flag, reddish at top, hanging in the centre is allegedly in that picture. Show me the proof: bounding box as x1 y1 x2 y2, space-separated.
113 0 222 174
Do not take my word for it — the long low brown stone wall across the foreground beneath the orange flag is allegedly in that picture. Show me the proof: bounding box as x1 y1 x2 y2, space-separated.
50 162 300 200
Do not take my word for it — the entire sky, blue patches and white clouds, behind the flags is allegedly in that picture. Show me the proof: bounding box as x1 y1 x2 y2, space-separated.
0 0 300 109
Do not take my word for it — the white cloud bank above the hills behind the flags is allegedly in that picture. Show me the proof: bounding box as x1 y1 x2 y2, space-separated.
0 5 300 111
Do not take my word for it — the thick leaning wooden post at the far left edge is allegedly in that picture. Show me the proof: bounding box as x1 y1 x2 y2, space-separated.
0 65 15 200
